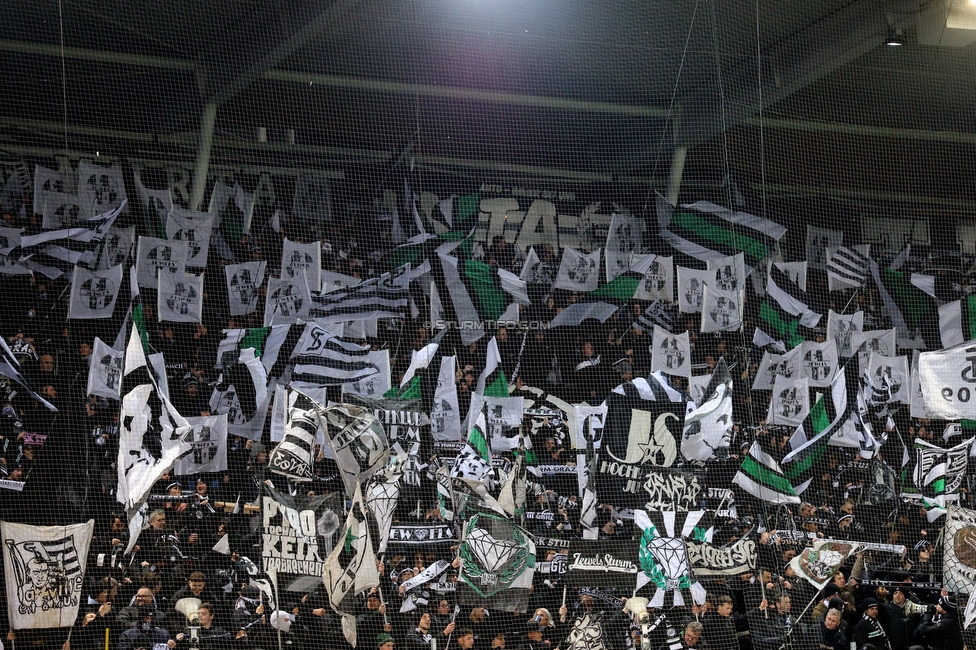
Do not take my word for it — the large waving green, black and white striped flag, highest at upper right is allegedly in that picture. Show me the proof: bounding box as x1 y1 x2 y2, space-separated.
656 194 786 275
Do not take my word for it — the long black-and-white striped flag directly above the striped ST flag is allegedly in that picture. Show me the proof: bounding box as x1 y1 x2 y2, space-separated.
308 264 410 325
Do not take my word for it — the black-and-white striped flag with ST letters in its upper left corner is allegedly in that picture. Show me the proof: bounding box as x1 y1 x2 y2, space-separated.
289 323 379 385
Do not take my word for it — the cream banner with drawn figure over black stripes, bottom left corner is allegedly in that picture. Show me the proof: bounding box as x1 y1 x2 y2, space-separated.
0 519 95 630
